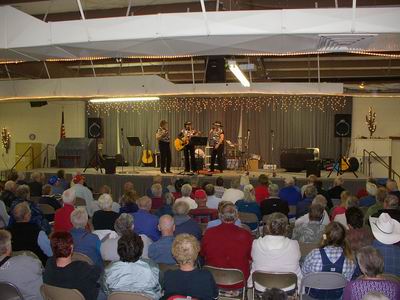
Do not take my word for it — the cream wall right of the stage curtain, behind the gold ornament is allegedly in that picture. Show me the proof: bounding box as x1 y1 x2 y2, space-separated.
352 97 400 177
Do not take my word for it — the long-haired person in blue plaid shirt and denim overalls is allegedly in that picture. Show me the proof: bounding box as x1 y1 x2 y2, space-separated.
302 222 356 299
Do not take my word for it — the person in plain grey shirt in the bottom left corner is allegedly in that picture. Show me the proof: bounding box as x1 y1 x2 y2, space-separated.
0 229 43 300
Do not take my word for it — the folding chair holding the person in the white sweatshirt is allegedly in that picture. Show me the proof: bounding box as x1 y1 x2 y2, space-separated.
251 271 297 300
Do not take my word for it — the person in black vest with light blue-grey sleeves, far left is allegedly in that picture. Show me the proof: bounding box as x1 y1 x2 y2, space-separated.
8 202 52 265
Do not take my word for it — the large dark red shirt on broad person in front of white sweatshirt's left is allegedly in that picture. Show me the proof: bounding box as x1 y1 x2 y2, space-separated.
200 223 253 289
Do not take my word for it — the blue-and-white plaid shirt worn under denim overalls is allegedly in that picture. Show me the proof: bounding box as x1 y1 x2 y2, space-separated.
301 246 356 280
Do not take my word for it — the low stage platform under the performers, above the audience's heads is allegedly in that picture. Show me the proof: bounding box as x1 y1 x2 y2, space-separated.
24 166 367 199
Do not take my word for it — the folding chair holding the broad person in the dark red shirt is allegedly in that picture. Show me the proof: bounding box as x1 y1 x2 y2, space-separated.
203 266 246 300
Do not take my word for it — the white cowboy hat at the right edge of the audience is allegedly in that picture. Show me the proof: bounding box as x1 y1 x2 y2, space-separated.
369 213 400 245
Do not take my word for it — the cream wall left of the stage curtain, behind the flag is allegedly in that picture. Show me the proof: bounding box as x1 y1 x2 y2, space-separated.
0 101 86 170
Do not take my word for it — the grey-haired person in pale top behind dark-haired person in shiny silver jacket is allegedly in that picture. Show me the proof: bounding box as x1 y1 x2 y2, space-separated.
100 213 152 261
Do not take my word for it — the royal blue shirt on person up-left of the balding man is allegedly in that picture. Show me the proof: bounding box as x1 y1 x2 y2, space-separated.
132 209 161 242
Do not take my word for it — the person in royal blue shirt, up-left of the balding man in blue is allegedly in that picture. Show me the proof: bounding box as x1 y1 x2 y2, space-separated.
133 196 160 242
